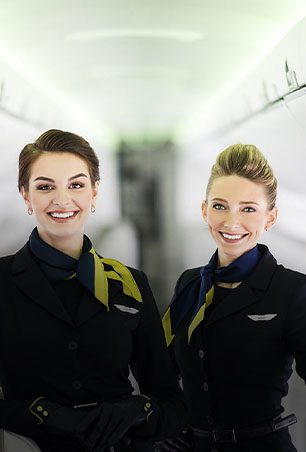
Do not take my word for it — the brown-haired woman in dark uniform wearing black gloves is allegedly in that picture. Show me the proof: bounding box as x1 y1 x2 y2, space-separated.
0 130 185 452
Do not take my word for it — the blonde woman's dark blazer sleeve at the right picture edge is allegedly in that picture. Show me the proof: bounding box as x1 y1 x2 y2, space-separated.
285 278 306 383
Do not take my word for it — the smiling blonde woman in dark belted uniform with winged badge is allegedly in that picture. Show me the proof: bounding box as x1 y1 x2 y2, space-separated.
160 144 306 452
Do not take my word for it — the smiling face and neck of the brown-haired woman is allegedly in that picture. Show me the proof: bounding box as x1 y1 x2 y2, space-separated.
21 152 98 249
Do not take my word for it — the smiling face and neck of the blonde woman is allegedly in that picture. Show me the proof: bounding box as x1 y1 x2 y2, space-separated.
202 175 277 266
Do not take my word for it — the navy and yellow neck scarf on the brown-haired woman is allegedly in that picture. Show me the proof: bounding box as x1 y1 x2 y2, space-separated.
29 228 142 310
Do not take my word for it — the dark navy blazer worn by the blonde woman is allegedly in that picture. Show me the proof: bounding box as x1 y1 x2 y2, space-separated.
172 245 306 429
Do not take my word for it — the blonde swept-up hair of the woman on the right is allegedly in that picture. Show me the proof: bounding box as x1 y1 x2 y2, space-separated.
206 143 277 210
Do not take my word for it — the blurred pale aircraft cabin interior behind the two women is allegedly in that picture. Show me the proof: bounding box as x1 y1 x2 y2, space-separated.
0 0 306 451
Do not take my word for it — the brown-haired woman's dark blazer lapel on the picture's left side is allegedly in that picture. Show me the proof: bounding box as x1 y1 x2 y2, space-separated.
12 244 75 326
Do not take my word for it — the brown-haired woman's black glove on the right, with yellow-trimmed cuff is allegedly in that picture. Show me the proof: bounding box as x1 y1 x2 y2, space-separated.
82 395 153 451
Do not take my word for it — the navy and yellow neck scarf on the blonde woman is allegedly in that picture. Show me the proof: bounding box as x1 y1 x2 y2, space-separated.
163 245 261 346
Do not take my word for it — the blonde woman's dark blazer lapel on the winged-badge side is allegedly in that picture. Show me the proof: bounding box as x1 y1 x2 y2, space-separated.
205 246 277 327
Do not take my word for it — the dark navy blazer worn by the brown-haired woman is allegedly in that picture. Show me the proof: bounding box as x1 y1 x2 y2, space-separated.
0 244 185 450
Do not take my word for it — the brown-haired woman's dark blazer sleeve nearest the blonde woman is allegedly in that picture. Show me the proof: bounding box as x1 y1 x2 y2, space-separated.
132 272 186 439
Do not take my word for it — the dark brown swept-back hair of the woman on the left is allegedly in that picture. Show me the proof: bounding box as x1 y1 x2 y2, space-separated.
18 129 100 191
